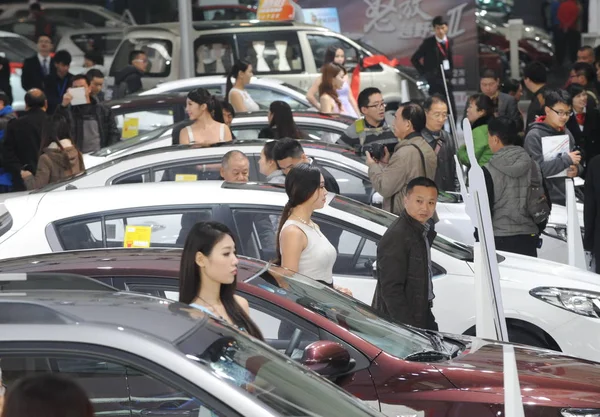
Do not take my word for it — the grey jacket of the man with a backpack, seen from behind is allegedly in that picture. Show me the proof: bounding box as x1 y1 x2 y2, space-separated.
486 146 542 237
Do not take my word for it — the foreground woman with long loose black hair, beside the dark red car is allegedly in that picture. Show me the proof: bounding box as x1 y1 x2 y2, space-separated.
179 222 263 340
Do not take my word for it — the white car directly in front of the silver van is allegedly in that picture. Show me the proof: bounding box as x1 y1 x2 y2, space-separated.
141 75 313 110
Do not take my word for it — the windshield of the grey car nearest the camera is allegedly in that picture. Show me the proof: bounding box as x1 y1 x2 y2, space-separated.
173 304 380 417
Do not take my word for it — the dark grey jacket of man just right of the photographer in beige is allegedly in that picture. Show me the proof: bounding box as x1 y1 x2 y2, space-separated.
421 128 456 191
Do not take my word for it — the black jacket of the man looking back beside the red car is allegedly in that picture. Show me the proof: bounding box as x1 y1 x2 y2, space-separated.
373 210 436 328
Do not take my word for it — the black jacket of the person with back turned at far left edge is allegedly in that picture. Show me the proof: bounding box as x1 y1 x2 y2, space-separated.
1 109 47 191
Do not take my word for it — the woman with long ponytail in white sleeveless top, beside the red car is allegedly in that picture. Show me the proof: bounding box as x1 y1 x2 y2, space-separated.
276 164 352 295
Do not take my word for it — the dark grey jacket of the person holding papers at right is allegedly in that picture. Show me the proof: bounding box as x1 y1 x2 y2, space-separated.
524 122 583 206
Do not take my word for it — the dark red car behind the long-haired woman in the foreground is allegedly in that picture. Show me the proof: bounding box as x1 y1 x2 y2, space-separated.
0 249 600 417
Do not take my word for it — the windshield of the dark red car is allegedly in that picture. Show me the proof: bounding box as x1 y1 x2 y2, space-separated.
246 266 434 358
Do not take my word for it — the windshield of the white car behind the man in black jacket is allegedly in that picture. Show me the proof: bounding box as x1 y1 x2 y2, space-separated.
329 195 476 262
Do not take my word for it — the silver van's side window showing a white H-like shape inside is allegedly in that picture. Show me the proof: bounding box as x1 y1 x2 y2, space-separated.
237 31 304 74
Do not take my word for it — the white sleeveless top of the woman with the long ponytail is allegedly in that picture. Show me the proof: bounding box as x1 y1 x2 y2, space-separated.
280 220 337 285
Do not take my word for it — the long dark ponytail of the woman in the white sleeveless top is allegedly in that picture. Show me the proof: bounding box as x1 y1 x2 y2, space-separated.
273 164 321 265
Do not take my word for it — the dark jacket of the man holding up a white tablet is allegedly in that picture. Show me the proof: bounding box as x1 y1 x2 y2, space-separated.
57 97 121 149
